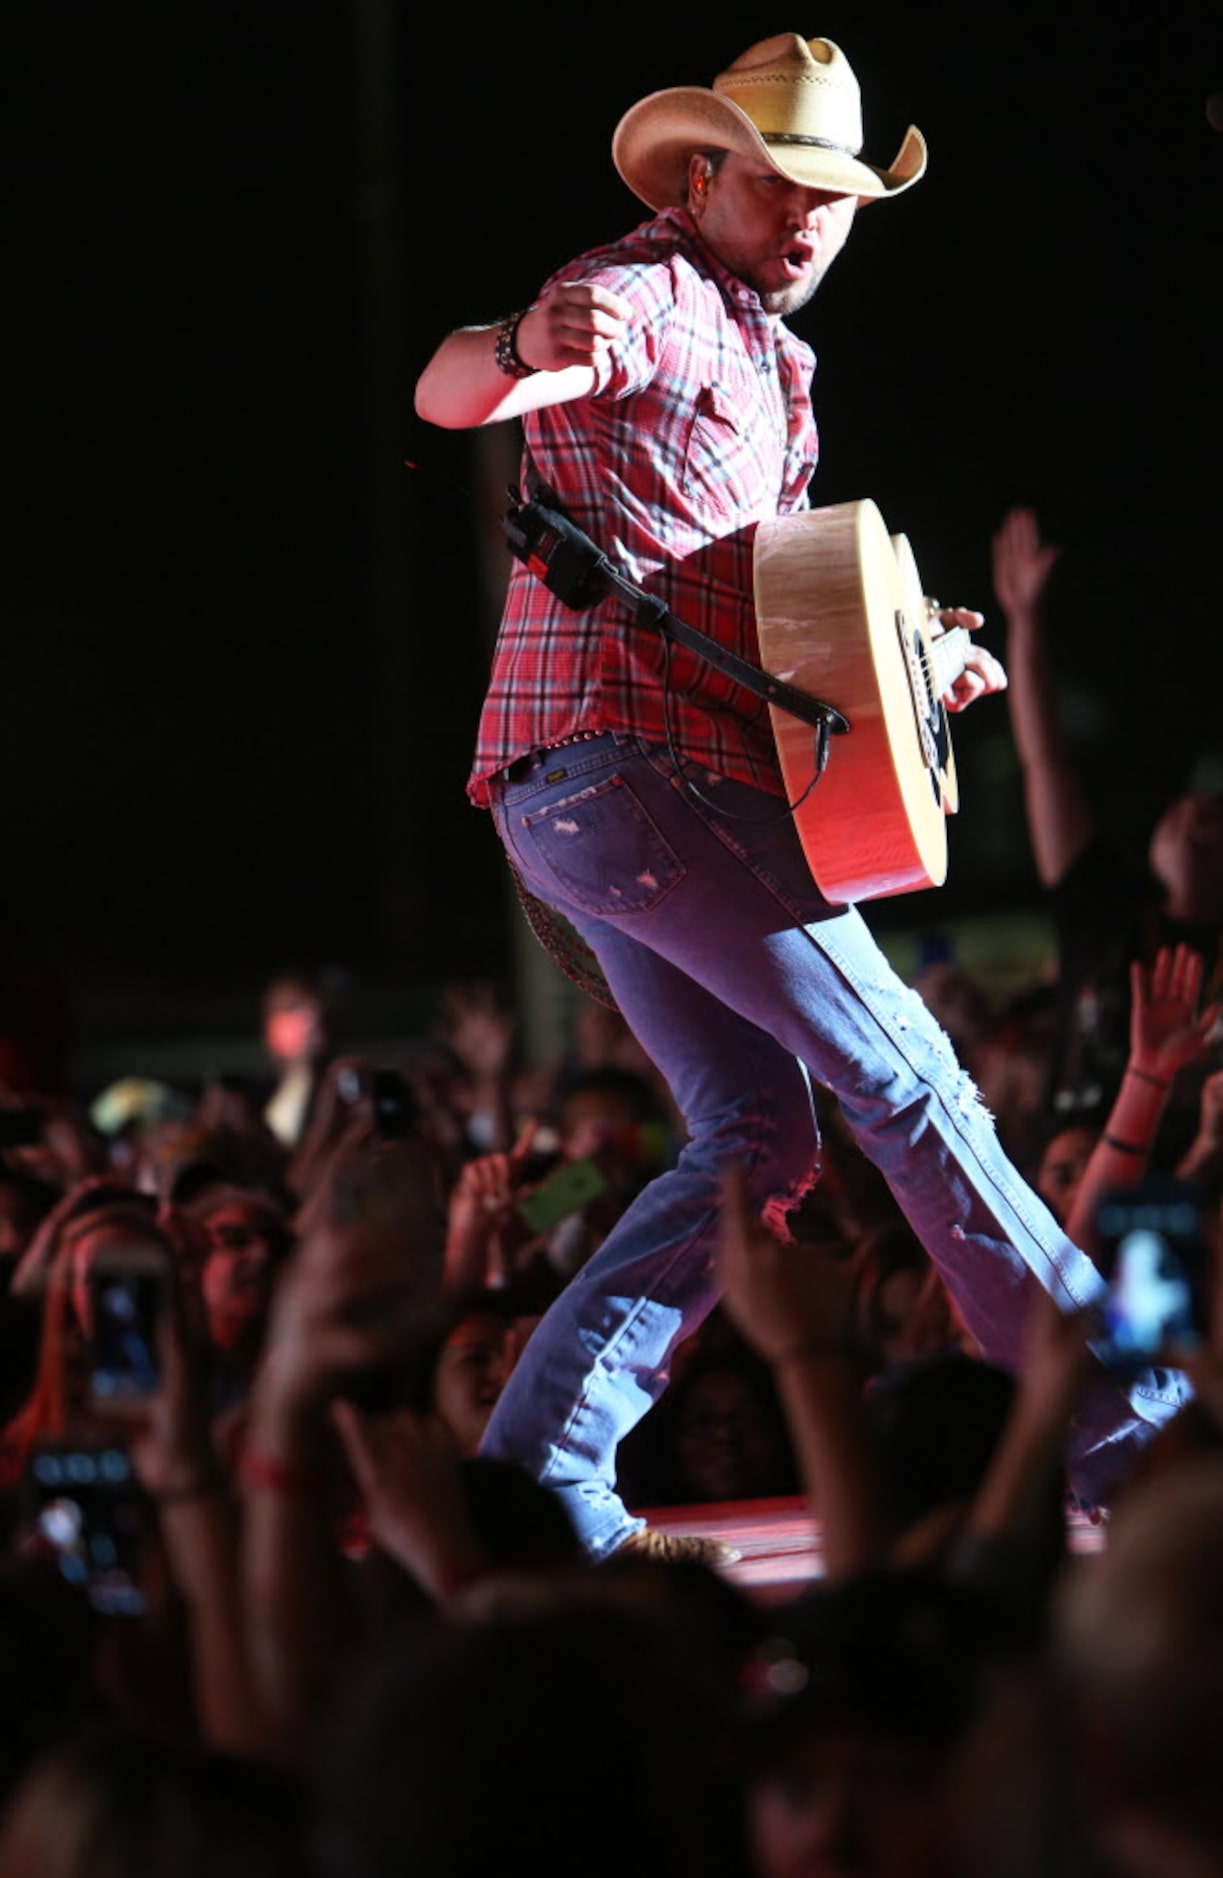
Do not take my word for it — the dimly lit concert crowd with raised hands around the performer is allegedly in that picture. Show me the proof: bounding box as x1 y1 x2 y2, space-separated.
0 597 1223 1878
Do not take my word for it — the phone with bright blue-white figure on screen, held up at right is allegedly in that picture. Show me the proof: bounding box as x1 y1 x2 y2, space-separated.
1097 1181 1206 1367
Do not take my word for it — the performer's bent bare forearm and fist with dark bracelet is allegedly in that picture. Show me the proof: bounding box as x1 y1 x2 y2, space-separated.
415 280 629 430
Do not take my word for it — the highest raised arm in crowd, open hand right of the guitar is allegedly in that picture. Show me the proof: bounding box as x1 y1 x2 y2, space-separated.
994 509 1093 886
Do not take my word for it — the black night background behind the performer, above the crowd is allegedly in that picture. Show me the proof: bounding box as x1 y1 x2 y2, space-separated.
0 0 1223 1081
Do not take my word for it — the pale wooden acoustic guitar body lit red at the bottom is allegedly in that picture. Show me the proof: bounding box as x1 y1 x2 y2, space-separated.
753 501 966 901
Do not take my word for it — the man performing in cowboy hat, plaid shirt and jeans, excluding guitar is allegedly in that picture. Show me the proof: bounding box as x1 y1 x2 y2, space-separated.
417 34 1185 1559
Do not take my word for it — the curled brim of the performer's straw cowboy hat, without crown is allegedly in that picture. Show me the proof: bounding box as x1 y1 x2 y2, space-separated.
612 85 926 210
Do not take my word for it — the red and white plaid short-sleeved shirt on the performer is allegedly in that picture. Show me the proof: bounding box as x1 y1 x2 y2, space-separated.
468 208 817 806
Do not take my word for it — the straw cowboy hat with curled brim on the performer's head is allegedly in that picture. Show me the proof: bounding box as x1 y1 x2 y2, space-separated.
612 32 926 208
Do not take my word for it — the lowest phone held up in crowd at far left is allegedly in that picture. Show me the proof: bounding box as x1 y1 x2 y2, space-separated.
26 1440 148 1617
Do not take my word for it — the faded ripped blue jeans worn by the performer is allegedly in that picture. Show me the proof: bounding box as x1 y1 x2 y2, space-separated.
483 732 1185 1557
